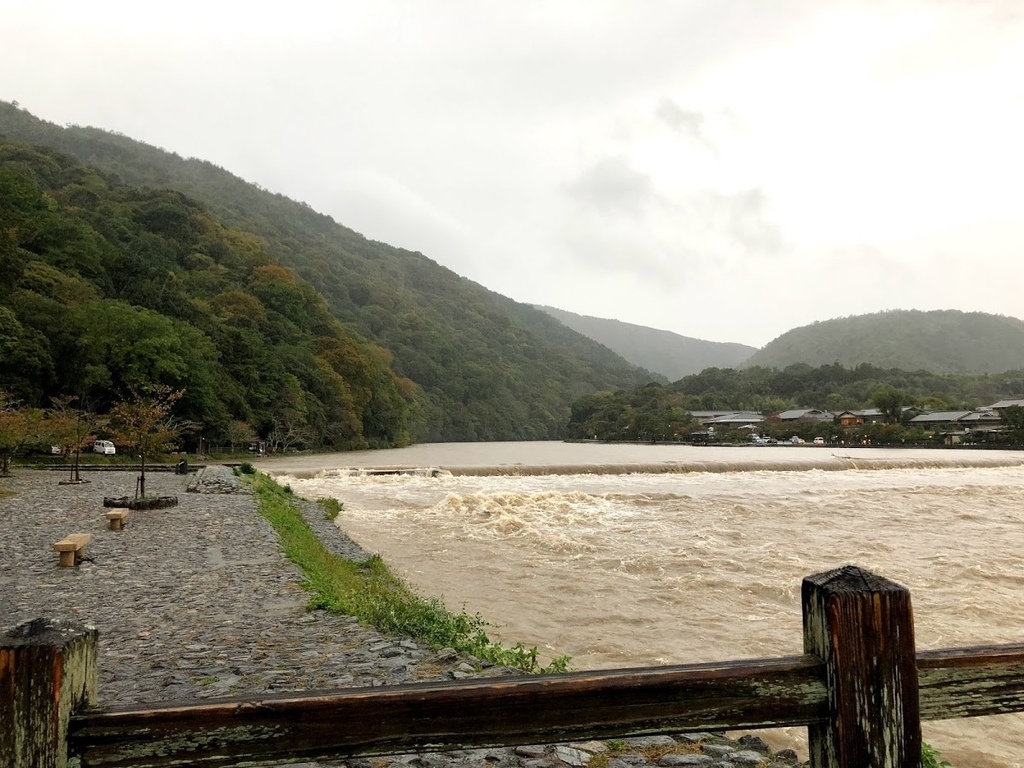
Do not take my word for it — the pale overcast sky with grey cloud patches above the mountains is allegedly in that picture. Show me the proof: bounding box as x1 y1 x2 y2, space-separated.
0 0 1024 346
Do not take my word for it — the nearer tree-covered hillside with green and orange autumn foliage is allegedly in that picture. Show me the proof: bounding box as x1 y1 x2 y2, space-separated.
0 139 416 449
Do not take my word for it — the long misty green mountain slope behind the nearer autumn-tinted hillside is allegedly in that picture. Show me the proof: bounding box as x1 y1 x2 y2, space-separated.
0 102 651 440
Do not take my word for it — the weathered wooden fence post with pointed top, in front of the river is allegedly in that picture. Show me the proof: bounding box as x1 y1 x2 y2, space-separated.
803 565 921 768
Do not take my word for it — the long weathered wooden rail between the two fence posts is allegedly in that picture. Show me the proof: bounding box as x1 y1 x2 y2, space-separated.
69 656 826 767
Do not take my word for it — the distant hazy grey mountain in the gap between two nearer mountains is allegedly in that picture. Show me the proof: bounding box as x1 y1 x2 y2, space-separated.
538 306 757 381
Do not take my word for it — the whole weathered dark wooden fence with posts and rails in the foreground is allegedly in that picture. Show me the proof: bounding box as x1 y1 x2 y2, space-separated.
0 566 1024 768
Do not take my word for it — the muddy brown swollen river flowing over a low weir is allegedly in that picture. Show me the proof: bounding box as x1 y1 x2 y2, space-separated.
261 442 1024 768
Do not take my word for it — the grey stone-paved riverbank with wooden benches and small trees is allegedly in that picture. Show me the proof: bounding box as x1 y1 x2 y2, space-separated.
0 467 797 768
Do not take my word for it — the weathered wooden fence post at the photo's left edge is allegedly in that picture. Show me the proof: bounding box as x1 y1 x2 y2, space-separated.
0 618 98 768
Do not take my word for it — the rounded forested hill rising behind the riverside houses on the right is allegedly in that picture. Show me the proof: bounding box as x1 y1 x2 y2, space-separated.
744 309 1024 373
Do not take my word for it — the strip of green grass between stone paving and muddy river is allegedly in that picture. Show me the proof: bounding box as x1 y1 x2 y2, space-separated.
247 474 569 673
